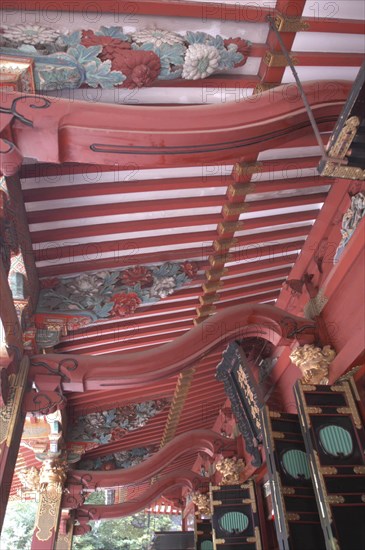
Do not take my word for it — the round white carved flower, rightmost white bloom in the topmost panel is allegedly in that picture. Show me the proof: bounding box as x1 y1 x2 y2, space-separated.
182 44 220 80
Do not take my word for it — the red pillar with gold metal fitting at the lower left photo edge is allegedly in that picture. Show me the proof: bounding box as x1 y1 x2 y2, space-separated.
0 356 29 531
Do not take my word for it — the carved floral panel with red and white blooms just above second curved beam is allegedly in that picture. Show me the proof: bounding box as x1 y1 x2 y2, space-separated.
36 261 198 330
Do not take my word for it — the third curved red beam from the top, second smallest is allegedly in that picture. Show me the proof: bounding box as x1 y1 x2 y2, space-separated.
68 430 235 488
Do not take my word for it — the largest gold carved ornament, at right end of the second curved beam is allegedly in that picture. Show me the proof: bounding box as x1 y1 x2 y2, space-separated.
290 344 336 385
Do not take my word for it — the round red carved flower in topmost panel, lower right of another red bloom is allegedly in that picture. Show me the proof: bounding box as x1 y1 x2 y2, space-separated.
112 50 161 88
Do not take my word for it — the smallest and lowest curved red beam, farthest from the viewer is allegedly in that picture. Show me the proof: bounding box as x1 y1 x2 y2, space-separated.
75 470 208 523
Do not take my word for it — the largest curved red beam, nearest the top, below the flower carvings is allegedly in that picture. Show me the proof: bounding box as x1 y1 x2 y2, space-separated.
0 81 352 169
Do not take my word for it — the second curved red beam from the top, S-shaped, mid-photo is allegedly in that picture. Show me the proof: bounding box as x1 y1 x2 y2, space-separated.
30 304 315 391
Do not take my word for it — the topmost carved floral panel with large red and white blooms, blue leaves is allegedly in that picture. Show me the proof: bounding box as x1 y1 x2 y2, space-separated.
0 24 251 90
